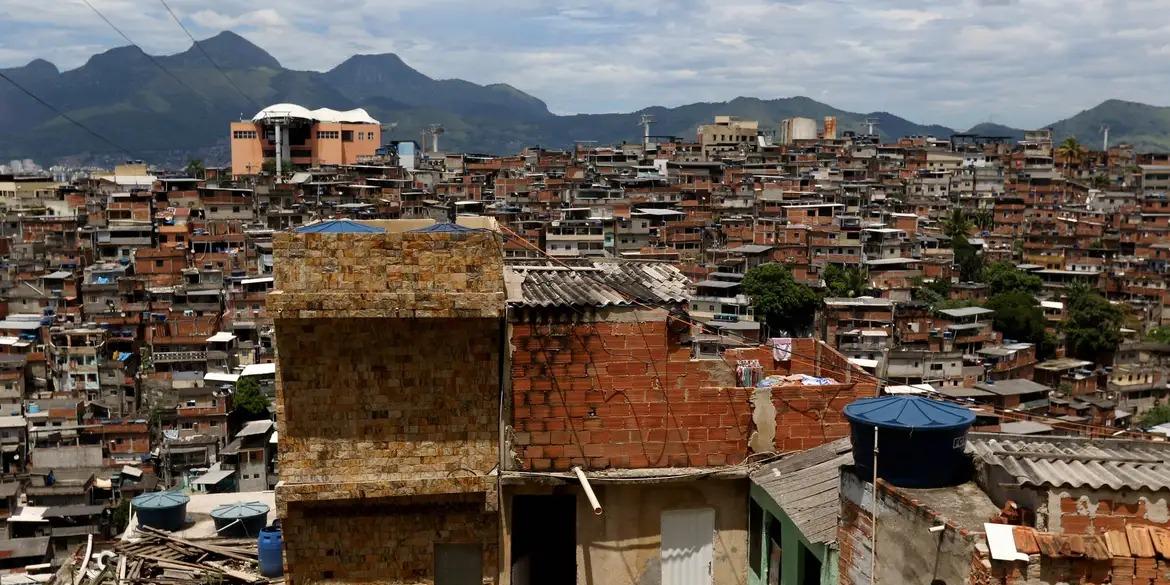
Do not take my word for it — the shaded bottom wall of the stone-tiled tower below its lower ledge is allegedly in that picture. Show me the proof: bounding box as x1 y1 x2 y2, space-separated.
283 496 498 585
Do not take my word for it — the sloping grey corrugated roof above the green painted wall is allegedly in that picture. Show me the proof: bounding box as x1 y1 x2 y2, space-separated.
751 438 853 543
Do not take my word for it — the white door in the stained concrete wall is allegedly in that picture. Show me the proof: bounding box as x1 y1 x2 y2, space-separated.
662 508 715 585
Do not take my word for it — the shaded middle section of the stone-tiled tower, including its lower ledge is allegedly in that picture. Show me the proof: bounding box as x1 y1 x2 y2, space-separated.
276 319 500 483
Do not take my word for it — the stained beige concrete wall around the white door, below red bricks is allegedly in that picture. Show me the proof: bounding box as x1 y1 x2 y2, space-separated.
503 479 748 585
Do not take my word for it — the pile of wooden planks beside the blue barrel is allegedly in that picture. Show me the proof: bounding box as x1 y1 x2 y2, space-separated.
74 527 269 585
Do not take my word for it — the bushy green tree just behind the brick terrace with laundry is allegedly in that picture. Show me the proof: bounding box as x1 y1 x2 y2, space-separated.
742 263 820 335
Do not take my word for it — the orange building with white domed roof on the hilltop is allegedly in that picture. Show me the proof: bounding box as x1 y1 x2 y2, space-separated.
230 104 381 176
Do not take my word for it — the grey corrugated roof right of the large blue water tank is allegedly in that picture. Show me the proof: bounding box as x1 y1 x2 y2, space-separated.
968 433 1170 490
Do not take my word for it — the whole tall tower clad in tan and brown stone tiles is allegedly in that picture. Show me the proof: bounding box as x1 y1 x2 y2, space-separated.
268 227 504 585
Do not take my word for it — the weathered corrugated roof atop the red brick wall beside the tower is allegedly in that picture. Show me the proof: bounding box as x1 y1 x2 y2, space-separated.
504 261 690 307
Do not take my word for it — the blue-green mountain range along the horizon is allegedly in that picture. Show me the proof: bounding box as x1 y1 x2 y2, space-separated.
0 32 1170 165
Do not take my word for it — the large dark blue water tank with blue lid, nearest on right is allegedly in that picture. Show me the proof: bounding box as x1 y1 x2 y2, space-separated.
845 395 975 488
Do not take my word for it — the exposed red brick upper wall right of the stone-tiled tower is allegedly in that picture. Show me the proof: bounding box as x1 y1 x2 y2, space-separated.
510 311 875 470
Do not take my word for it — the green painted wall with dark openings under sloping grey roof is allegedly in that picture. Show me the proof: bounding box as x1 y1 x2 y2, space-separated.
748 483 838 585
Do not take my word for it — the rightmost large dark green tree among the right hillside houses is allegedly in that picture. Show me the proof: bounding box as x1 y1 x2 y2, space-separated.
1064 285 1124 362
